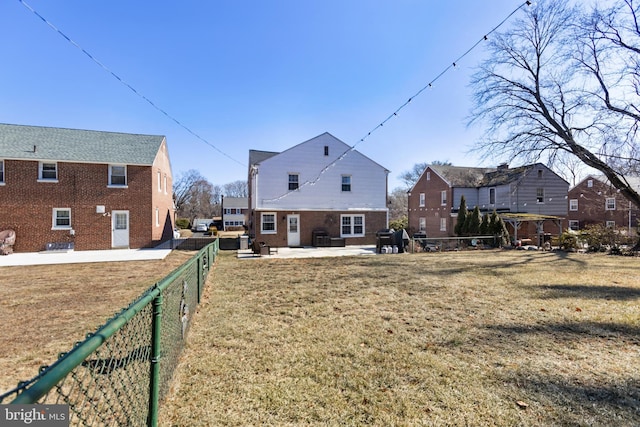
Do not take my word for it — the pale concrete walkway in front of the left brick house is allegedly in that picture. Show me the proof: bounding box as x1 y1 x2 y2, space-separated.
0 249 171 268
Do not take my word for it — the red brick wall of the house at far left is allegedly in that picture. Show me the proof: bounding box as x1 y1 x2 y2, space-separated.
0 160 165 252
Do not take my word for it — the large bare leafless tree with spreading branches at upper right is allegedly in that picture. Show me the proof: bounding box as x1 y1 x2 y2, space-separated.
471 0 640 206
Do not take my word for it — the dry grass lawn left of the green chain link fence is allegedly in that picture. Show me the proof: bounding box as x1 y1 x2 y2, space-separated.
0 251 196 394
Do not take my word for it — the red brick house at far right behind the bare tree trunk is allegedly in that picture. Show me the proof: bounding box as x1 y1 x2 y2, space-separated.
568 175 640 230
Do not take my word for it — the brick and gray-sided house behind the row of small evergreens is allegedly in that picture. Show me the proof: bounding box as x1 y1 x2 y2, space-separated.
408 163 569 241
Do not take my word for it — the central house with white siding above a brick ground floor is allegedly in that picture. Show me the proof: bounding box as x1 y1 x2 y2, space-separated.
249 133 389 247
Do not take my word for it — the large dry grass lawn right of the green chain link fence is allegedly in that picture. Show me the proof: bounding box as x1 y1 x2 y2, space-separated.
158 251 640 426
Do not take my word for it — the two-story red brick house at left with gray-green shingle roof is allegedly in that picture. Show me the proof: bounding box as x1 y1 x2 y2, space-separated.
0 124 174 252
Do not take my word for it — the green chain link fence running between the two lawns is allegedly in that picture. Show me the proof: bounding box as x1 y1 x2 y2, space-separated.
0 240 219 426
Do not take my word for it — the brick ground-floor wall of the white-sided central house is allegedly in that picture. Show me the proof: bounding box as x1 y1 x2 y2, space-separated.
252 211 387 247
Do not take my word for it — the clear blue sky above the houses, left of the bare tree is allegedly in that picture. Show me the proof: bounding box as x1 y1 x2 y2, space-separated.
0 0 524 189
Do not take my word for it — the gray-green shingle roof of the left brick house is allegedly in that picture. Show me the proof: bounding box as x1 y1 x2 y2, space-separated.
0 123 165 165
